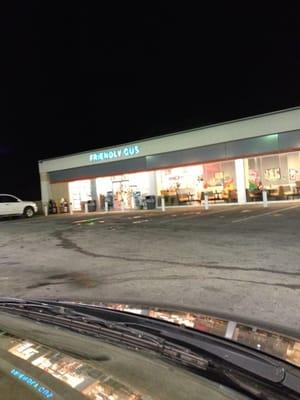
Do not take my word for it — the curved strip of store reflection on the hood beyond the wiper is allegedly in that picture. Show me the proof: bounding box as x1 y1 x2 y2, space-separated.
101 303 300 367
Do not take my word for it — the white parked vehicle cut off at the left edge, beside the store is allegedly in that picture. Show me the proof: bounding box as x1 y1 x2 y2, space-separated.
0 194 38 218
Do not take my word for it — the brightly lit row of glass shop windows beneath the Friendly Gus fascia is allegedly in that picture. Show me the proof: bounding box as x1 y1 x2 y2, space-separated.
69 151 300 211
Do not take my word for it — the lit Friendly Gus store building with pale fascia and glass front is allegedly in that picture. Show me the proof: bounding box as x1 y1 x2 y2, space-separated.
39 108 300 211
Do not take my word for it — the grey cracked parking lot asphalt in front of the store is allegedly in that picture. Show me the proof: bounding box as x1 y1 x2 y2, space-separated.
0 201 300 336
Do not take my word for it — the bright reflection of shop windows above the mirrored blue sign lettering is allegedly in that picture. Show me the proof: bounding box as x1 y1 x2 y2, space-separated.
8 338 151 400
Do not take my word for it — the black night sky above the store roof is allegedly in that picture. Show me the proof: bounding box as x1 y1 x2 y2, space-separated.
0 1 300 199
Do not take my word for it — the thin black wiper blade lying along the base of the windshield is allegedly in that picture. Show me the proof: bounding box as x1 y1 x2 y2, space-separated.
0 300 208 369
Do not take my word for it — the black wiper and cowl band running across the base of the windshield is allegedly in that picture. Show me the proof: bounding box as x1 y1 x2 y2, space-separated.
0 299 300 399
